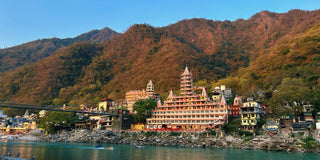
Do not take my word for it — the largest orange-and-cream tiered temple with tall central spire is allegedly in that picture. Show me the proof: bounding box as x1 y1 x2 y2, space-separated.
145 67 228 131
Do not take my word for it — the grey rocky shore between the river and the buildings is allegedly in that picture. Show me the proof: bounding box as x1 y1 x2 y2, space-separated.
30 130 320 153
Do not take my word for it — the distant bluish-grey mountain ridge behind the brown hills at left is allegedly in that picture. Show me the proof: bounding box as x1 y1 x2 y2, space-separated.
0 27 118 72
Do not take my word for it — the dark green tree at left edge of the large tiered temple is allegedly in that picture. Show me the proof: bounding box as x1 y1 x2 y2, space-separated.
133 98 157 123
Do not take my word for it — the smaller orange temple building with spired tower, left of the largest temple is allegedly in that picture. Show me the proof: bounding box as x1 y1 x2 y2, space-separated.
125 80 158 113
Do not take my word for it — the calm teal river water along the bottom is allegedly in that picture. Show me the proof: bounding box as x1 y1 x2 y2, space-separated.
0 140 320 160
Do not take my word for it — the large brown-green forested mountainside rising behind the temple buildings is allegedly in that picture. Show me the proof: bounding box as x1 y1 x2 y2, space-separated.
0 10 320 116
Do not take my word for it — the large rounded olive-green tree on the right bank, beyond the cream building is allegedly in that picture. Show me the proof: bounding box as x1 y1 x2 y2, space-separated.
270 78 310 115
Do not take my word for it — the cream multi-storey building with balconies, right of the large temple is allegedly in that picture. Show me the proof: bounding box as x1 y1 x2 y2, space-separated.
240 101 263 131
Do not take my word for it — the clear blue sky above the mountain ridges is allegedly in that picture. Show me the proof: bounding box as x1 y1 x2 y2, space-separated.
0 0 320 48
